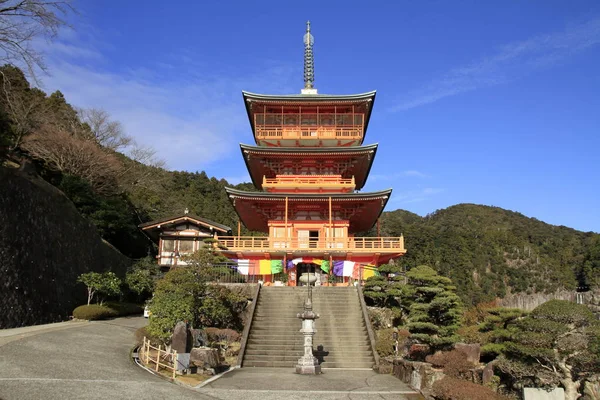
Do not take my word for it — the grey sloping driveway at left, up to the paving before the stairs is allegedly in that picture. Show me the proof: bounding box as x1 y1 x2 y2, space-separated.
0 317 209 400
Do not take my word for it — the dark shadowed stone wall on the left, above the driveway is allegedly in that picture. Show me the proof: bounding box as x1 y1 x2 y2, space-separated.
0 167 131 329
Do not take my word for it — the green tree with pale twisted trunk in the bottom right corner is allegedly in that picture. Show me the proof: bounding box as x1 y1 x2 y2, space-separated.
497 300 600 400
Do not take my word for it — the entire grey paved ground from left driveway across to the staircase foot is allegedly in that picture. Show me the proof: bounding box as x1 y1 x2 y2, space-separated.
0 317 419 400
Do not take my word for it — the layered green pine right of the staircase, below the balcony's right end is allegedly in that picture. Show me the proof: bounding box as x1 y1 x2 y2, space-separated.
405 265 461 349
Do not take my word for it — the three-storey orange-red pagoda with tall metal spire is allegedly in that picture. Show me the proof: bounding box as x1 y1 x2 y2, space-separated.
218 22 406 286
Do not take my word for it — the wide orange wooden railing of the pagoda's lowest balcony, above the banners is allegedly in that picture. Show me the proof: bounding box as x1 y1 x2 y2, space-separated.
217 236 406 253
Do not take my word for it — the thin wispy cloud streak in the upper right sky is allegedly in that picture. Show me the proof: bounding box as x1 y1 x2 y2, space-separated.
390 18 600 111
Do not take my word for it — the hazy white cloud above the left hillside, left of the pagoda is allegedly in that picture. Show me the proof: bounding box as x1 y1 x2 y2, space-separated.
35 30 297 170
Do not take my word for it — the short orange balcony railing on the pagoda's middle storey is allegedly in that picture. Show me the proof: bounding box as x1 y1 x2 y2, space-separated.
262 175 356 192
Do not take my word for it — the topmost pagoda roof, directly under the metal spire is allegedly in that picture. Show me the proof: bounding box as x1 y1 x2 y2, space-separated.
242 90 377 143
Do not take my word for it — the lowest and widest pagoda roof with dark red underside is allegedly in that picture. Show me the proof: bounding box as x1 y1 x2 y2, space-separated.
225 187 392 232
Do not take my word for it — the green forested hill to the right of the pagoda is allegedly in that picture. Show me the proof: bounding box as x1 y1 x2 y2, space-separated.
369 204 600 304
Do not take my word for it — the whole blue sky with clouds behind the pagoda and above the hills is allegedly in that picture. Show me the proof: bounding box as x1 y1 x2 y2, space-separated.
38 0 600 232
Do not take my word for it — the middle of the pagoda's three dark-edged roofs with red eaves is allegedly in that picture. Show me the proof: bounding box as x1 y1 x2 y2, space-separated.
240 144 378 189
